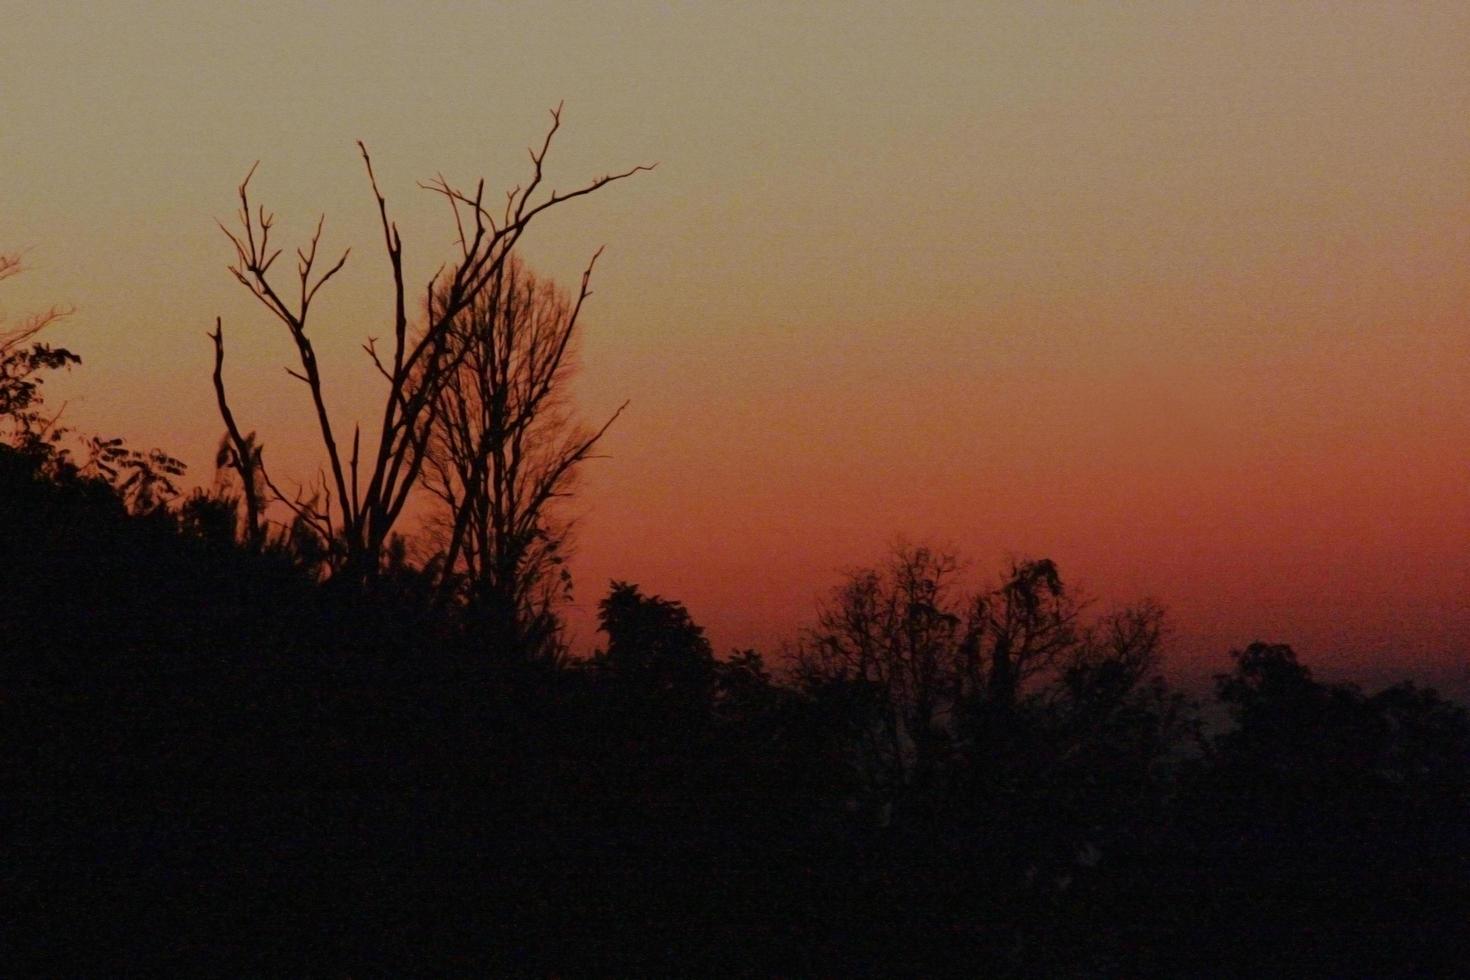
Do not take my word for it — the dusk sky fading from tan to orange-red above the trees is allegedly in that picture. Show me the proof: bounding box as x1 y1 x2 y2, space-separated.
0 0 1470 691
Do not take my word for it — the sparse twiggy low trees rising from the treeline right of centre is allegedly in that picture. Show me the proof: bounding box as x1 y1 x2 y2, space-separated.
797 545 1163 796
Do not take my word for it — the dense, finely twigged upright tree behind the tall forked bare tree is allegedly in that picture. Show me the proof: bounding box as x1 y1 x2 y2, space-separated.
423 254 622 657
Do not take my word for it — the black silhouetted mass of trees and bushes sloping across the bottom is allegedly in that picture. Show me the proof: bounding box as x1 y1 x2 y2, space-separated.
0 439 1470 977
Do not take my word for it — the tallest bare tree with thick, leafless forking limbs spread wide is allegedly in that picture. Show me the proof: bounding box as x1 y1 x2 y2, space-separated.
212 106 651 582
